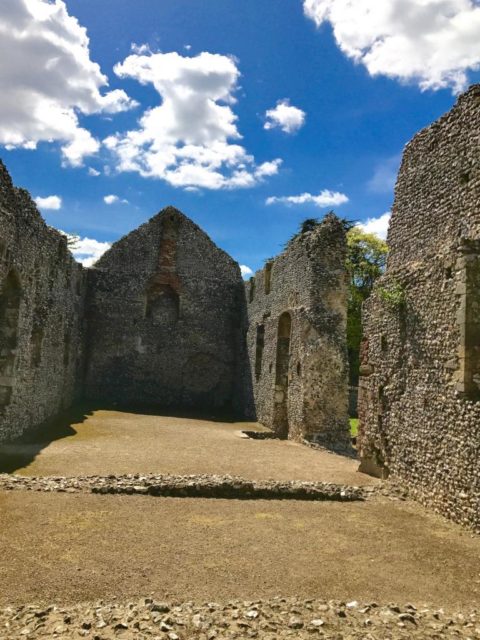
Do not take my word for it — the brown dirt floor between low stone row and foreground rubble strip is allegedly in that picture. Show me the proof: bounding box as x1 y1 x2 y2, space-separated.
0 492 480 607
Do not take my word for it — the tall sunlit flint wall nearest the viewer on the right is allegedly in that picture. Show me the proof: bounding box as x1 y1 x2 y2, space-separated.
358 85 480 529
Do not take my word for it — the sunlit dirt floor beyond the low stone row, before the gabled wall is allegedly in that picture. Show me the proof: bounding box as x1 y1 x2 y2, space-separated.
0 410 376 485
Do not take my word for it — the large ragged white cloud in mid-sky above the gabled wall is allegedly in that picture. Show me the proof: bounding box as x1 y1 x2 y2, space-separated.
104 47 281 189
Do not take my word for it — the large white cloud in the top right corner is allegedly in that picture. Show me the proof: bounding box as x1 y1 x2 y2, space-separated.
304 0 480 92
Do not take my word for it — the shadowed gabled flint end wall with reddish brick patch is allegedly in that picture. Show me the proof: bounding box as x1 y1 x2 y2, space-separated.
86 207 243 409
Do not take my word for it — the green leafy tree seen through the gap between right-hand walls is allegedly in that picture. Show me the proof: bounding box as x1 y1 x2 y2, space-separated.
347 226 388 386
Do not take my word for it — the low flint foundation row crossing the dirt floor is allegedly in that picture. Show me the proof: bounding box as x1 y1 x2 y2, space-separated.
0 474 375 502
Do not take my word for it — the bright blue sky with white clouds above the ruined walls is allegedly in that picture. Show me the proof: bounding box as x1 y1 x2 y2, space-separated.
0 0 480 270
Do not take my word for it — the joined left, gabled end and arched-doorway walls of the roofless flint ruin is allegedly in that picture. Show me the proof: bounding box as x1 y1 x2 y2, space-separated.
0 163 348 445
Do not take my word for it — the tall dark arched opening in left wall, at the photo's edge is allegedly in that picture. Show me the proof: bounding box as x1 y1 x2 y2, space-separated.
0 271 22 411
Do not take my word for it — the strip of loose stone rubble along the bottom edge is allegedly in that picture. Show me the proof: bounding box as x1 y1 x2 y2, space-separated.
0 597 480 640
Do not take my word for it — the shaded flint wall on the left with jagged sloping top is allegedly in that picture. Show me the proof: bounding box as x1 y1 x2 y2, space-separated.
0 162 84 441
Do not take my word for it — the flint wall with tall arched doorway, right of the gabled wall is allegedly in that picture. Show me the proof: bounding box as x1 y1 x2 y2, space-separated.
246 214 349 446
